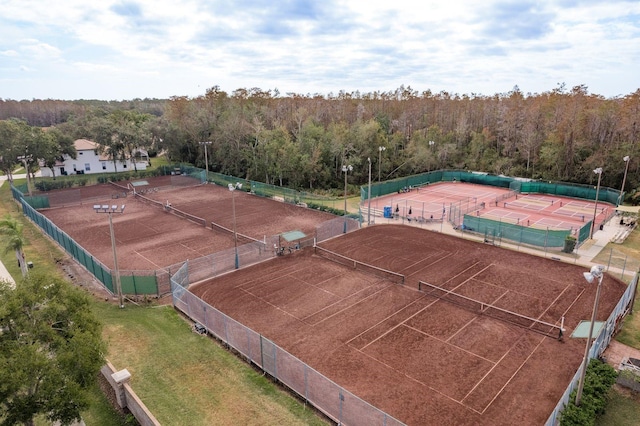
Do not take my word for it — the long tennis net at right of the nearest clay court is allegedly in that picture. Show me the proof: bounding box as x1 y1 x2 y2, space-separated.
418 281 564 339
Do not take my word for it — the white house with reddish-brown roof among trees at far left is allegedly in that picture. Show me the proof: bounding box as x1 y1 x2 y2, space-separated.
40 139 149 177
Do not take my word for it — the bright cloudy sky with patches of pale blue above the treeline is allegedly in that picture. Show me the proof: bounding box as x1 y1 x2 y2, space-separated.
0 0 640 100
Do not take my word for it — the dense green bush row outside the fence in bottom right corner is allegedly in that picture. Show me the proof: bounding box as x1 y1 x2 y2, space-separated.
560 359 618 426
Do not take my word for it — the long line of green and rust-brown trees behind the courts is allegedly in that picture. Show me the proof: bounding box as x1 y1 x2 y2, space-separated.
0 84 640 201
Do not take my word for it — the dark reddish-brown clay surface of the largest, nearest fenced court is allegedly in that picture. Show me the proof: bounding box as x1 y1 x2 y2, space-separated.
191 225 626 425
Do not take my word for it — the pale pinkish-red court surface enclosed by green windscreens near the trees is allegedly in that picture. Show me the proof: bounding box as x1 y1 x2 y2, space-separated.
362 182 614 230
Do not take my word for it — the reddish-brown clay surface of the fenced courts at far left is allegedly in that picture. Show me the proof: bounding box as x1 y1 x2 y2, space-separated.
40 176 335 270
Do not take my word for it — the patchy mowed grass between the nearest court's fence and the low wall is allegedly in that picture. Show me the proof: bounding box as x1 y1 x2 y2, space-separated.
95 302 328 425
